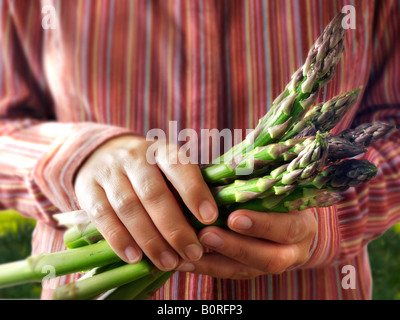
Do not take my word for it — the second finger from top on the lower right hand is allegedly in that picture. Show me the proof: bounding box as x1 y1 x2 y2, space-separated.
199 227 300 274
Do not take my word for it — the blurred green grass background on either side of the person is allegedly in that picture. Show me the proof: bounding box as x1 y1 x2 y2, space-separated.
0 210 400 300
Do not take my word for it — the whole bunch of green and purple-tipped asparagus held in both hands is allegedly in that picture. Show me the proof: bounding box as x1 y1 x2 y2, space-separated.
0 14 393 300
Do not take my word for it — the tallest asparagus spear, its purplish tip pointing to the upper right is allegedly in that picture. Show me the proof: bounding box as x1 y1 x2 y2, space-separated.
214 13 345 163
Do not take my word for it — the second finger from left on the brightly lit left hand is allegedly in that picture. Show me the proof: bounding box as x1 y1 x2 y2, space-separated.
103 174 179 271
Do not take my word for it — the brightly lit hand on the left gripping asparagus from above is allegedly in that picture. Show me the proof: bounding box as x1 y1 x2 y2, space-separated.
75 135 218 271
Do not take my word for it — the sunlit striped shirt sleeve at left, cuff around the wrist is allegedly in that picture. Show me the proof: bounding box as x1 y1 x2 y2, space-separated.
0 0 131 225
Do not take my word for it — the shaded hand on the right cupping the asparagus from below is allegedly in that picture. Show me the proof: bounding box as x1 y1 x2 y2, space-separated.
178 209 317 279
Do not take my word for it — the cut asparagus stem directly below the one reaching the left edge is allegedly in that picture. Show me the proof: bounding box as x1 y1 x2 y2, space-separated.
52 260 156 300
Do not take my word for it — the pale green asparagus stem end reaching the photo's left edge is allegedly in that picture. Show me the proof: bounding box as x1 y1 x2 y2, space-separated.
0 241 120 287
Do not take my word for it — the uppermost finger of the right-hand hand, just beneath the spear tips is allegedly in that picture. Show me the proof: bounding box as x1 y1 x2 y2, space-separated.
228 210 316 244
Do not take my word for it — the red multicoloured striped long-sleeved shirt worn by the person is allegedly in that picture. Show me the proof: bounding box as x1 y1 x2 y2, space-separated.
0 0 400 299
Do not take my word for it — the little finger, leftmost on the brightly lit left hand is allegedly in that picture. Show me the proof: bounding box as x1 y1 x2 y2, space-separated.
78 183 142 264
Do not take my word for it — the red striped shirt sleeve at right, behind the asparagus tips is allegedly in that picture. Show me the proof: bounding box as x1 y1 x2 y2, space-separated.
304 1 400 267
